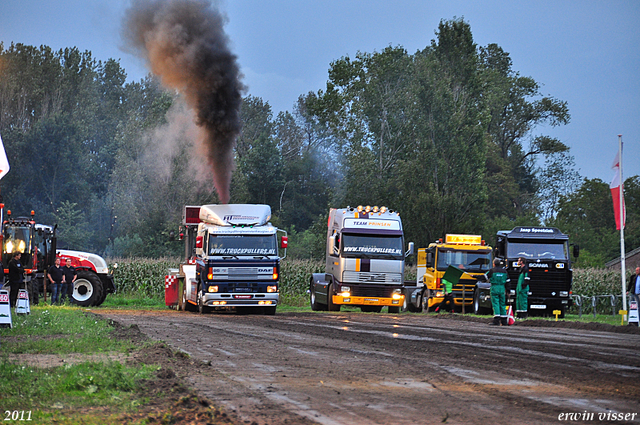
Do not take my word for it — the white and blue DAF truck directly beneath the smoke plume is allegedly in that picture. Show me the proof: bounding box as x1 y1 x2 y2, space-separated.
171 204 287 315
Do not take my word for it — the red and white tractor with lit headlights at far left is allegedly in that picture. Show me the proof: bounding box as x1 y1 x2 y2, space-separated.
0 204 116 307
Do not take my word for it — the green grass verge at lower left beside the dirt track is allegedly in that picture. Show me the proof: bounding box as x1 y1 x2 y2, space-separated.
0 306 157 424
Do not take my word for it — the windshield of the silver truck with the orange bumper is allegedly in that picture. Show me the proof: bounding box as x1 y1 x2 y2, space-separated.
342 234 404 260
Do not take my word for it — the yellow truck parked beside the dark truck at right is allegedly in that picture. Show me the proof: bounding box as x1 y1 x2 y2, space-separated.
417 234 492 312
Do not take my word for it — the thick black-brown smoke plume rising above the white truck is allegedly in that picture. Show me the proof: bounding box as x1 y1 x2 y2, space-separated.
123 0 244 203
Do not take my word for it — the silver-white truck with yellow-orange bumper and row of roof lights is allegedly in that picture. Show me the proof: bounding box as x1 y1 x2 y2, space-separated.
308 206 414 313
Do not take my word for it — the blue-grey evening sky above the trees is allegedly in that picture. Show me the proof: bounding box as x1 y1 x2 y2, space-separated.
0 0 640 182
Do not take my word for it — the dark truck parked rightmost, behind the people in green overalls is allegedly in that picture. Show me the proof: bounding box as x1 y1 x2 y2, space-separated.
495 227 579 317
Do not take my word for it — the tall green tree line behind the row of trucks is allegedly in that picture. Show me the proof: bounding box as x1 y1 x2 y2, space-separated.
0 19 640 266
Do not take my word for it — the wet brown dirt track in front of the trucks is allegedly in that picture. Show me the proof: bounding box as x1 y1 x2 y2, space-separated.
94 309 640 425
